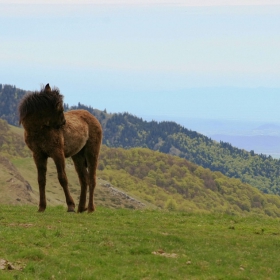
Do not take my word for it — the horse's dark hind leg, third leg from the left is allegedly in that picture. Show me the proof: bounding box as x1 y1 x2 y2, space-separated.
72 152 88 213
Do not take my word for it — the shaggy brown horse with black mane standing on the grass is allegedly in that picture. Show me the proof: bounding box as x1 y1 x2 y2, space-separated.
19 84 102 213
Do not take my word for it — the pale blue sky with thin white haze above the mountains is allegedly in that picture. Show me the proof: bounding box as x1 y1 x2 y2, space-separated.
0 0 280 122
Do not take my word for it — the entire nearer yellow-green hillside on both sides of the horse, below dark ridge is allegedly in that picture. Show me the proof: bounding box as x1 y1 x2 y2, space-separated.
0 120 280 217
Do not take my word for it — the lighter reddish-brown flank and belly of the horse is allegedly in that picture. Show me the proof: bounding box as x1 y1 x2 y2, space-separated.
63 118 89 157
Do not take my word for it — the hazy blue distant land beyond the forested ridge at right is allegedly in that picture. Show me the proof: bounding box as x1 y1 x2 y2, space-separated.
136 115 280 158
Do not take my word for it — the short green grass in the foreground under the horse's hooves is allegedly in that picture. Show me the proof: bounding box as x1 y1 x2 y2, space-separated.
0 205 280 280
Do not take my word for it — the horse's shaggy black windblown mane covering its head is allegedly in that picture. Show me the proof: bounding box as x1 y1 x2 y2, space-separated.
18 84 63 124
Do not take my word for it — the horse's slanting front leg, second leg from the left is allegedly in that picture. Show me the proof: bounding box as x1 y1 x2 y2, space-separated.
53 154 75 212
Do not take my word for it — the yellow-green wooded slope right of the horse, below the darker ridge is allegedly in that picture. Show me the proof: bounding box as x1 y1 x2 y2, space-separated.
99 146 280 217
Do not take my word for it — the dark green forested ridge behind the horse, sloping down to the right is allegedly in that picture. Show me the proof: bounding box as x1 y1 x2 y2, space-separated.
0 85 280 194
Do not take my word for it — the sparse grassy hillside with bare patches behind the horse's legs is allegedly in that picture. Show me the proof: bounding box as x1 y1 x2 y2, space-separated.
0 119 148 209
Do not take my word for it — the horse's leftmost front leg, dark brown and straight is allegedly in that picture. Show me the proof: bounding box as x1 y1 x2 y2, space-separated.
33 153 48 212
